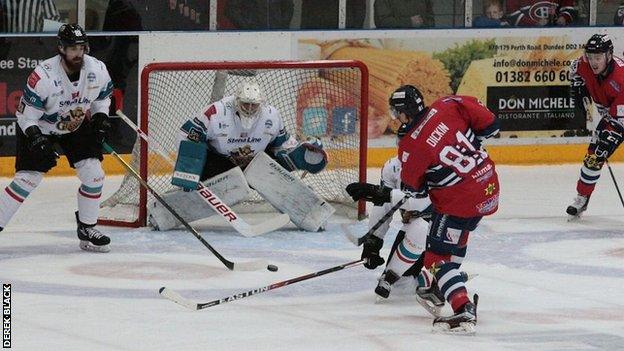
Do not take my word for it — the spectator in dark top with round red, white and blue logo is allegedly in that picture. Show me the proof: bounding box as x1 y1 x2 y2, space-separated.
506 0 578 27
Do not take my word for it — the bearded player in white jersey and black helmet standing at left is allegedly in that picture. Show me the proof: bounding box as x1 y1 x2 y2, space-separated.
0 24 113 252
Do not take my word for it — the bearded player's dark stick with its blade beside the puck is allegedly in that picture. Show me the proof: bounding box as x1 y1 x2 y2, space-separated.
102 143 267 271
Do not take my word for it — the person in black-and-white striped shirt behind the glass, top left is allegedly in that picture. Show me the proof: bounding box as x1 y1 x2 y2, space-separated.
0 0 61 33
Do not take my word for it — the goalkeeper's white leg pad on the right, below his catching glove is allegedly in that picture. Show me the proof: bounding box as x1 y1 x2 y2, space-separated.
245 152 335 232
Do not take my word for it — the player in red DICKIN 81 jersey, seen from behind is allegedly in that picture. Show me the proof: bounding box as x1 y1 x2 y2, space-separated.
347 85 499 332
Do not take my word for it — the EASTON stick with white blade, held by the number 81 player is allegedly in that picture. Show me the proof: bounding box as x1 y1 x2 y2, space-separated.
158 260 366 310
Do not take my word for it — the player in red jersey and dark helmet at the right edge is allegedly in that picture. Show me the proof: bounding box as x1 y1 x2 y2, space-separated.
566 34 624 217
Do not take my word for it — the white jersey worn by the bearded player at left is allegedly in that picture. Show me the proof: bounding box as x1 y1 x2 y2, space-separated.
16 55 113 135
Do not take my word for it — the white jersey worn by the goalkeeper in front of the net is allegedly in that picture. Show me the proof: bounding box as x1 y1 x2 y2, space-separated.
180 96 297 166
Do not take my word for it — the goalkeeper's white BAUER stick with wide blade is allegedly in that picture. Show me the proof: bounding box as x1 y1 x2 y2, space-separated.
117 110 290 238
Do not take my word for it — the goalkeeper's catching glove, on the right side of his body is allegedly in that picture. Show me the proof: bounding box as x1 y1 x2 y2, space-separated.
275 138 327 174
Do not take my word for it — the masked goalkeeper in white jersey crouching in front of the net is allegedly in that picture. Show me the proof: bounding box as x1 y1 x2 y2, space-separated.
149 81 327 230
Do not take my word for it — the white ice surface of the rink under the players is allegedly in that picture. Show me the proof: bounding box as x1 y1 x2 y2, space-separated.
0 163 624 351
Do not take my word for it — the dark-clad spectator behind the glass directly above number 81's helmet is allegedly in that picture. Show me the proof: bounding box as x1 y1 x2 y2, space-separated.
375 0 435 28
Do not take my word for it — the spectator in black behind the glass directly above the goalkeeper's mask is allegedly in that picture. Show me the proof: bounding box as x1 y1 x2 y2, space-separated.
225 0 294 30
